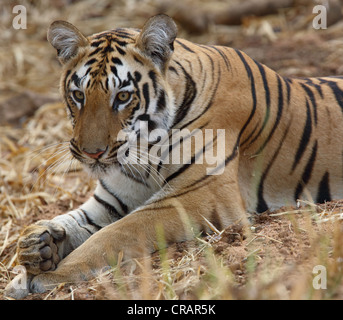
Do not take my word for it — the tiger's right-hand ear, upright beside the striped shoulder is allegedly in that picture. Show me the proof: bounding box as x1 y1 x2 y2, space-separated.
137 14 177 71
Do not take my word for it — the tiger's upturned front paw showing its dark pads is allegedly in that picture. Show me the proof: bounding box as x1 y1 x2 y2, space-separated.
17 220 66 275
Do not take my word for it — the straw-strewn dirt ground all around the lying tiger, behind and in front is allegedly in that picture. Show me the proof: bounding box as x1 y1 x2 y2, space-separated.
0 0 343 300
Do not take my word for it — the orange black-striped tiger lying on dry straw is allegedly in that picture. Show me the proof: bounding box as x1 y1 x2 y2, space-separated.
6 14 343 298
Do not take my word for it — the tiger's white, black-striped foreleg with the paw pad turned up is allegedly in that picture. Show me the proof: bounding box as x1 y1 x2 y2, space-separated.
13 183 126 275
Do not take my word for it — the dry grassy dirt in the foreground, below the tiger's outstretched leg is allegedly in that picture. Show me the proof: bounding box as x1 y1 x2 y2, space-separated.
0 199 343 300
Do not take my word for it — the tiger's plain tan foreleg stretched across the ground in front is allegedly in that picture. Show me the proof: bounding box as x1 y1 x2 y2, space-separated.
30 179 247 292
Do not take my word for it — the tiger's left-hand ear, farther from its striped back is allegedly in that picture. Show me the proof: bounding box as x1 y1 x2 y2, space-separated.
48 21 89 64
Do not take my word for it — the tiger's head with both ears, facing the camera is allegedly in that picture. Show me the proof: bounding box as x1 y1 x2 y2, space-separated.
48 15 177 175
